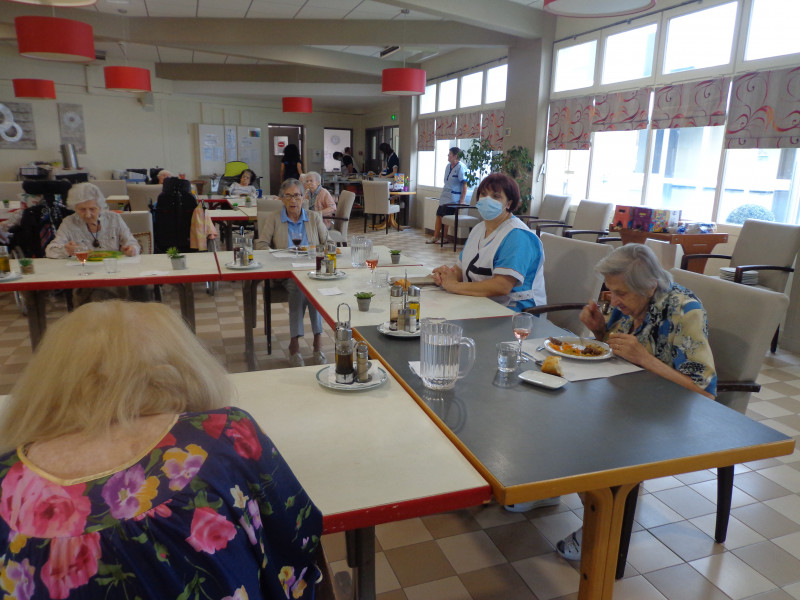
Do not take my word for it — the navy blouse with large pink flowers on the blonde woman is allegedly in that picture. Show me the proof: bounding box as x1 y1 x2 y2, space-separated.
0 408 322 600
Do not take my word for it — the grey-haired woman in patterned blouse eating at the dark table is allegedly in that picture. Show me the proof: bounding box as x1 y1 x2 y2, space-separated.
556 244 717 560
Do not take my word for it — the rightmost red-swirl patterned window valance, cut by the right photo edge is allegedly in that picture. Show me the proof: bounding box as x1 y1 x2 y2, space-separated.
725 67 800 148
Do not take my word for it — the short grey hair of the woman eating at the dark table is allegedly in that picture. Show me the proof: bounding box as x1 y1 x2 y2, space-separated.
595 244 672 296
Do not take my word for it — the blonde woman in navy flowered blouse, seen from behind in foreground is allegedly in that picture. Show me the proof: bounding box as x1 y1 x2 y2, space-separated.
0 301 322 600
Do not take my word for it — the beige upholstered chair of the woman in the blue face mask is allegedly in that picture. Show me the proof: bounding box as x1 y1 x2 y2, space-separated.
525 233 613 335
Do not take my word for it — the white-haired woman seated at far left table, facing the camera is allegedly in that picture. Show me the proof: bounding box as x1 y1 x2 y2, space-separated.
45 183 139 258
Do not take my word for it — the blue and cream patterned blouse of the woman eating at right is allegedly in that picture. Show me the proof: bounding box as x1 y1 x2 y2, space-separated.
606 283 717 396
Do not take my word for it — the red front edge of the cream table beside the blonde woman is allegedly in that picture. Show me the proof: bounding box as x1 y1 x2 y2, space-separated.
322 483 492 534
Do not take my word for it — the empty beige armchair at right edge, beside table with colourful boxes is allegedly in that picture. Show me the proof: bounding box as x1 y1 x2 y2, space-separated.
681 219 800 352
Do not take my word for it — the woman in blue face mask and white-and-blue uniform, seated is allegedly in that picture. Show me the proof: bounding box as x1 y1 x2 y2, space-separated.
433 173 547 312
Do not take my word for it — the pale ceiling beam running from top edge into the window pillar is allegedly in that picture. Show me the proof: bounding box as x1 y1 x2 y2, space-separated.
375 0 555 39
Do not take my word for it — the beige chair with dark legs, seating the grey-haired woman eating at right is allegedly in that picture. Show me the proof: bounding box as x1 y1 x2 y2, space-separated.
617 269 789 579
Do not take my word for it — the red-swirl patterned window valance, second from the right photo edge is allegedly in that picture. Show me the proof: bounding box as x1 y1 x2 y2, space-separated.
651 77 731 129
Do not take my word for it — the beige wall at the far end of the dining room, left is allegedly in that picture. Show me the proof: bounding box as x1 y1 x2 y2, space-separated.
0 46 365 184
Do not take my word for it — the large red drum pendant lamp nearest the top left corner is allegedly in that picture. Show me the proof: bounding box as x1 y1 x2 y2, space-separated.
14 16 95 62
